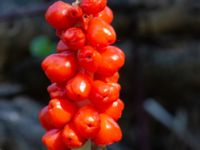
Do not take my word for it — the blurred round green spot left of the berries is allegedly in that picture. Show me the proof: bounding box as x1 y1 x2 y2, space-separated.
30 36 56 58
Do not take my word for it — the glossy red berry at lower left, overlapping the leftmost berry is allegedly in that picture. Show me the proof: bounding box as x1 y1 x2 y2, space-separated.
48 99 77 128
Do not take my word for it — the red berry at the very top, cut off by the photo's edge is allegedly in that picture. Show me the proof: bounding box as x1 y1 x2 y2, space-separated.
80 0 107 14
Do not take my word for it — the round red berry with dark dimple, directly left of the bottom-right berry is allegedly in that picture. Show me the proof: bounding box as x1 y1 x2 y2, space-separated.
73 105 100 138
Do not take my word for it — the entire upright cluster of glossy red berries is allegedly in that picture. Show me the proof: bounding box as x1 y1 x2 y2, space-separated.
39 0 125 150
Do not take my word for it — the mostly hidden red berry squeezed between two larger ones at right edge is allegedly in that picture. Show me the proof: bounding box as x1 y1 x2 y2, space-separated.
94 72 119 83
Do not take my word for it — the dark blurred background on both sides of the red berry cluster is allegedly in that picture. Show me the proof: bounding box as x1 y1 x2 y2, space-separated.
0 0 200 150
